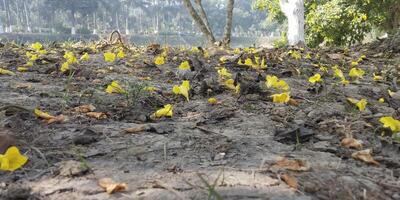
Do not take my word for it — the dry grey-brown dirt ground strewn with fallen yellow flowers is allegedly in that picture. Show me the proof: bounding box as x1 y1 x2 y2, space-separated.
0 38 400 200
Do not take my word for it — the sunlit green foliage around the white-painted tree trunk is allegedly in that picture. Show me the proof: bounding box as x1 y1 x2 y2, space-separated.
253 0 400 46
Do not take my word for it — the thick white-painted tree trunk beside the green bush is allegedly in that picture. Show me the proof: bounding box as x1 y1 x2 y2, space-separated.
280 0 305 45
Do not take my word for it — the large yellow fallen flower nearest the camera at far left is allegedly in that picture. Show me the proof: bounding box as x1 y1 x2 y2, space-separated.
0 146 28 171
